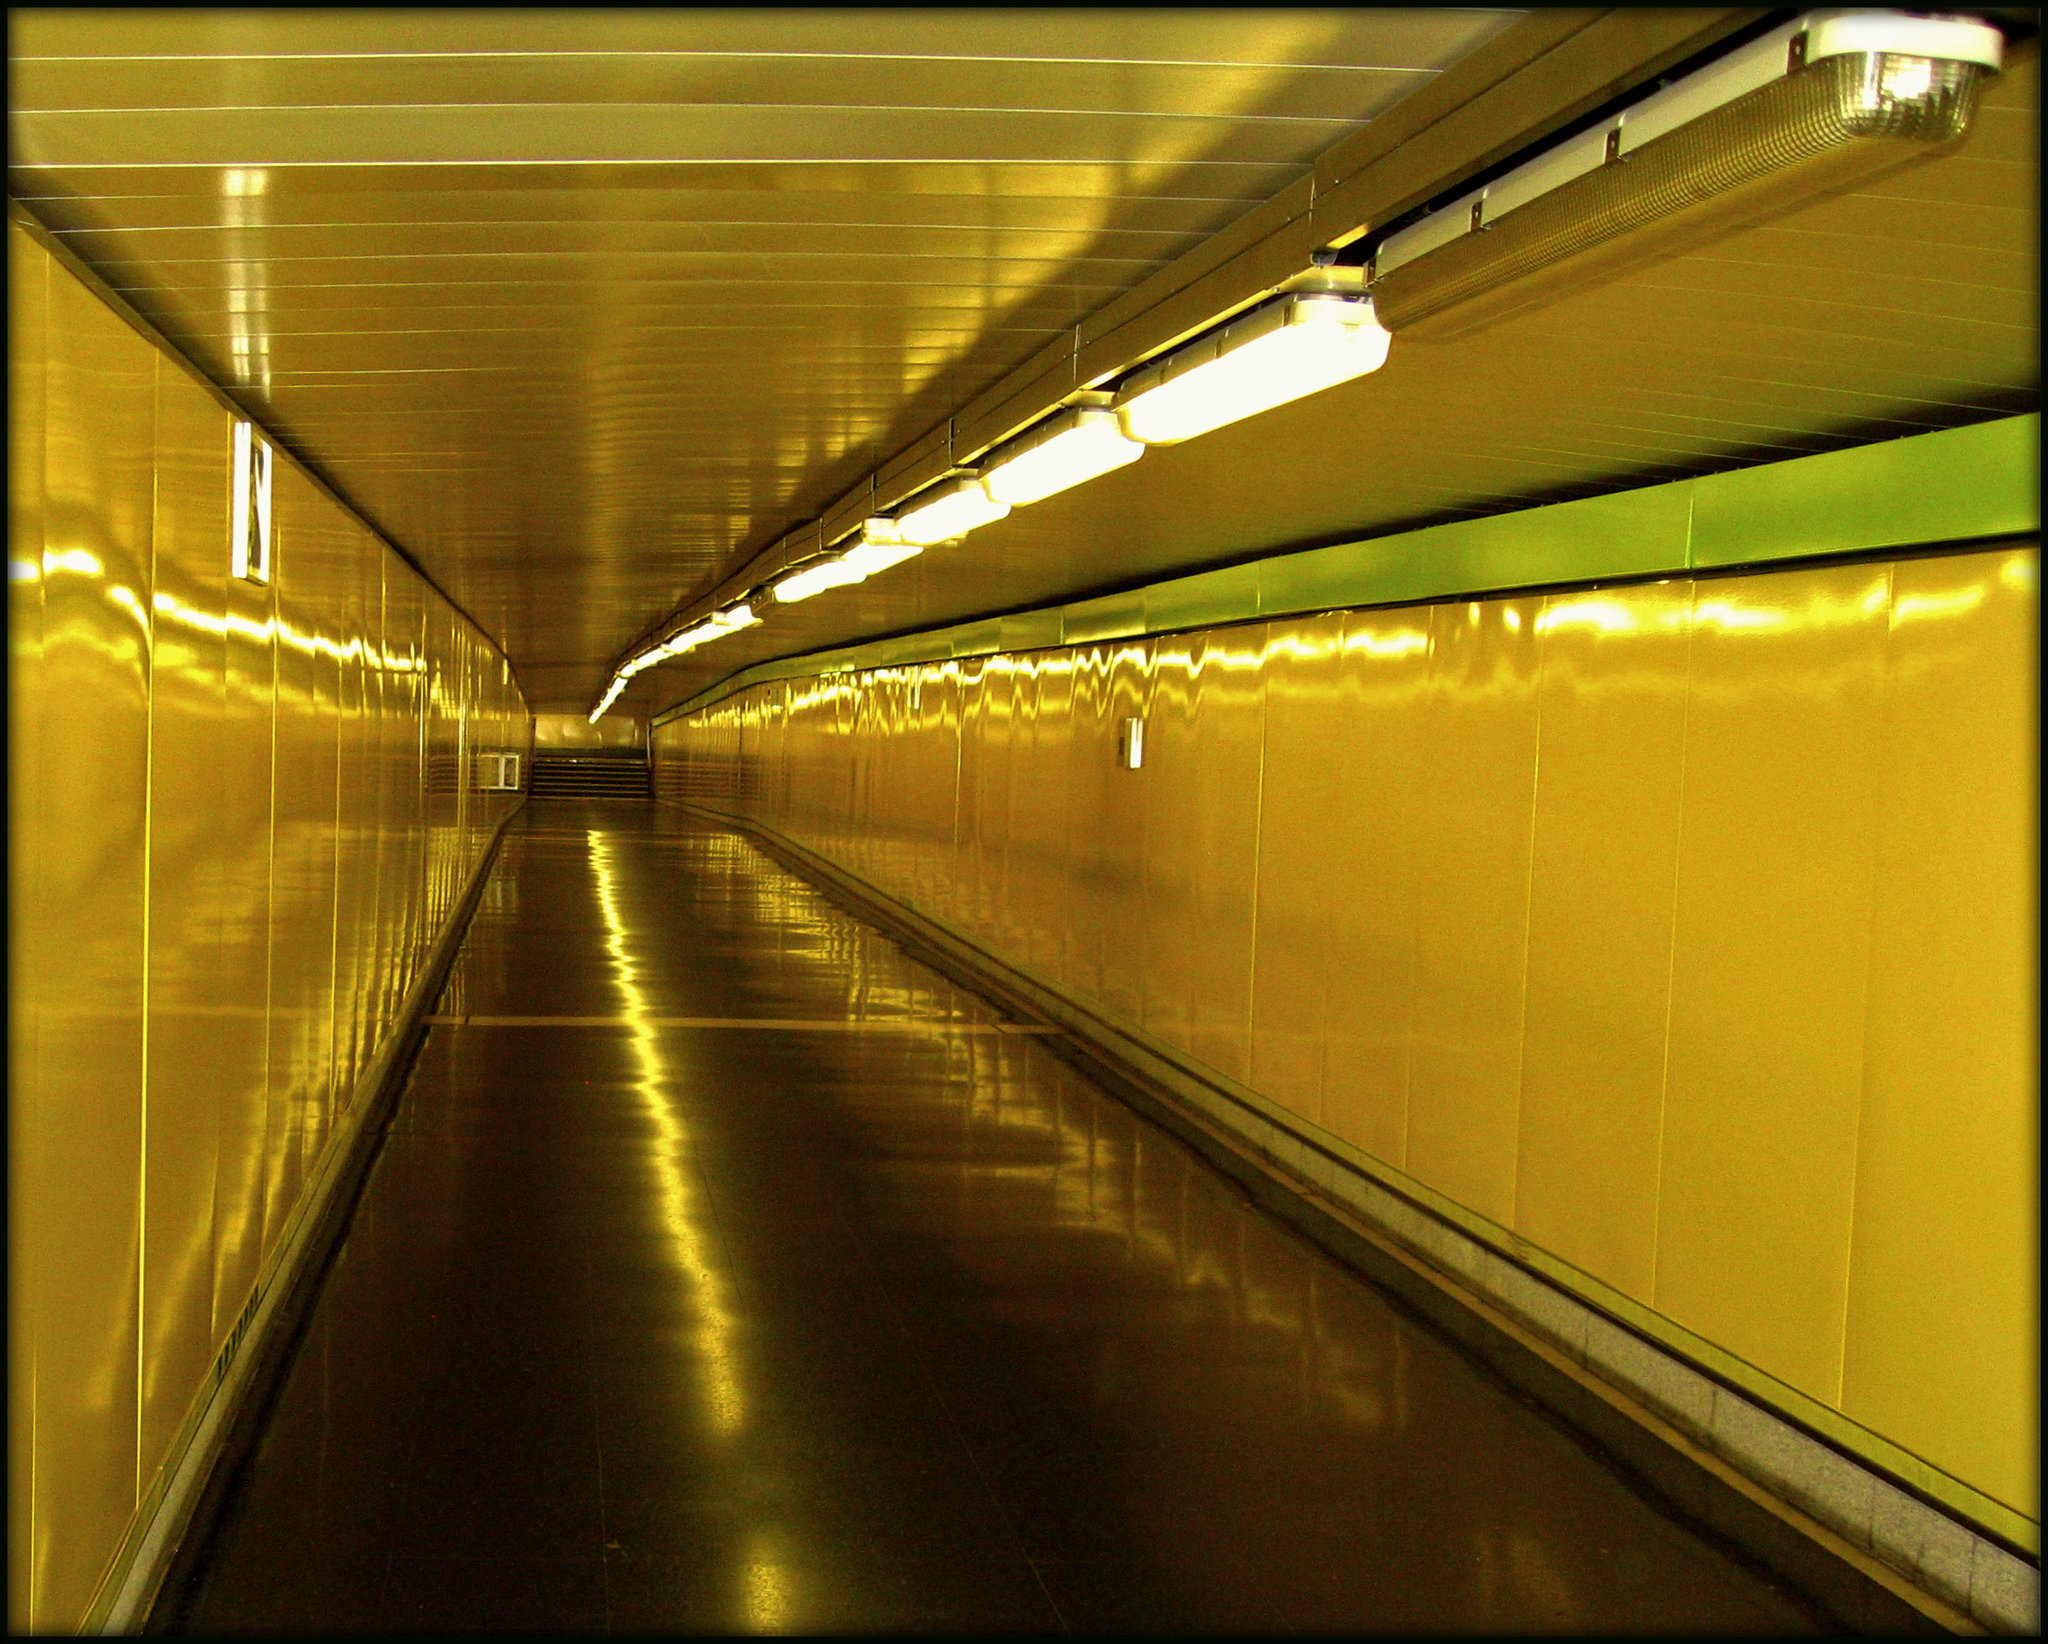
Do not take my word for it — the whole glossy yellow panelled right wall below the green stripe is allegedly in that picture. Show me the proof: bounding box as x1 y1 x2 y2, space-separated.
653 547 2038 1517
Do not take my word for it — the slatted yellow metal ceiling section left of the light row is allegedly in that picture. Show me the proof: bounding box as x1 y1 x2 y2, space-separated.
10 10 1531 708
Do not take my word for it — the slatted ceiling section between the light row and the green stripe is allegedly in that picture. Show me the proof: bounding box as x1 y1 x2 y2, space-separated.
623 24 2040 710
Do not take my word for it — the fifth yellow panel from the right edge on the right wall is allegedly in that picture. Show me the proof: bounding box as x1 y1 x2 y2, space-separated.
1323 610 1434 1167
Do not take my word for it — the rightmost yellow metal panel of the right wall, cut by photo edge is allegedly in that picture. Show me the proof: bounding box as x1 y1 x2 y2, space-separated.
1841 547 2040 1517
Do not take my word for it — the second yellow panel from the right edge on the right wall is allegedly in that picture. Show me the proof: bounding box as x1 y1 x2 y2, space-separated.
1655 565 1890 1402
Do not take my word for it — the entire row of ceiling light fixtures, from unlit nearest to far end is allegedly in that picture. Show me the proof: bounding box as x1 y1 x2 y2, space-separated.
592 10 2005 721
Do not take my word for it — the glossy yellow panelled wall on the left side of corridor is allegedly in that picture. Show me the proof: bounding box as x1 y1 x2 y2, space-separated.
8 227 526 1632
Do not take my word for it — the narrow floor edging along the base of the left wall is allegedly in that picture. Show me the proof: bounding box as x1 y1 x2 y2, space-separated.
118 801 524 1636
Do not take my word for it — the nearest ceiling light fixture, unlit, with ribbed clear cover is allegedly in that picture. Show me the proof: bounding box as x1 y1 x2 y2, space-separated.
1368 10 2005 340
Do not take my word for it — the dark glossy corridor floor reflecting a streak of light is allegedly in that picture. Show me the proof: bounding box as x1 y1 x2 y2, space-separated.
163 801 1810 1632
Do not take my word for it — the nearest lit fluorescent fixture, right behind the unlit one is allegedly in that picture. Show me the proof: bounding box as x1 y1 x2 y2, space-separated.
1116 293 1389 444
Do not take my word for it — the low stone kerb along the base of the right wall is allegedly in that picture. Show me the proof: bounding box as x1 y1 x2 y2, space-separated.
680 805 2040 1636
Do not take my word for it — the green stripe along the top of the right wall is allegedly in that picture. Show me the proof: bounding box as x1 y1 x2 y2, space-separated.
653 414 2042 725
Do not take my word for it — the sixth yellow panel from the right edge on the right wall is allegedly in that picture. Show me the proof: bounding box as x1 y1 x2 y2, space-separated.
1245 610 1356 1124
